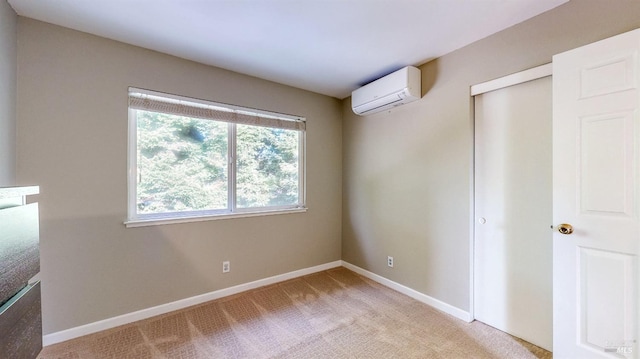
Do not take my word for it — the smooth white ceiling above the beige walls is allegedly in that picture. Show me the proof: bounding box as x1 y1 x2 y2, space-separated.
8 0 568 98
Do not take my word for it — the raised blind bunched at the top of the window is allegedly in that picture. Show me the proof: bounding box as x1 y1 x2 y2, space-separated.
129 88 306 131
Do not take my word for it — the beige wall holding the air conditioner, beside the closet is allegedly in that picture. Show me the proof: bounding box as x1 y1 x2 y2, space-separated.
342 0 640 310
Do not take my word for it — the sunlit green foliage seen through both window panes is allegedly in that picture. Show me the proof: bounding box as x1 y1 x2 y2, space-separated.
136 110 300 214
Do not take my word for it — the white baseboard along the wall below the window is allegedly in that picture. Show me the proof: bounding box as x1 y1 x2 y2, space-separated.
42 261 343 346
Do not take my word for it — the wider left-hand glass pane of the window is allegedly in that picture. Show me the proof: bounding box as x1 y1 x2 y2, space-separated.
136 110 229 214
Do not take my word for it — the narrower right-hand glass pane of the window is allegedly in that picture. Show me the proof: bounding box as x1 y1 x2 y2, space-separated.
236 125 300 208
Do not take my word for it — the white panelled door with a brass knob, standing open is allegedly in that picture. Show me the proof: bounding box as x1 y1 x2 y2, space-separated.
553 30 640 358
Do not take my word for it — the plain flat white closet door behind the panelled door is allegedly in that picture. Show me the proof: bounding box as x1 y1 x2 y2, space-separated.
473 77 553 350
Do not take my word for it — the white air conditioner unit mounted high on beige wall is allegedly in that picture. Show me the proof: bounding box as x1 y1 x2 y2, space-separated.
351 66 422 116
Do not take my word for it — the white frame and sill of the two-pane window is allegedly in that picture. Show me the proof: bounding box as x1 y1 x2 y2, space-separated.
124 87 307 227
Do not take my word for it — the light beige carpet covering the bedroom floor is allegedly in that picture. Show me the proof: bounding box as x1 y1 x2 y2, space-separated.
38 268 551 359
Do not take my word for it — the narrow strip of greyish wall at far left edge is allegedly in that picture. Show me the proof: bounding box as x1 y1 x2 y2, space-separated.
0 0 18 187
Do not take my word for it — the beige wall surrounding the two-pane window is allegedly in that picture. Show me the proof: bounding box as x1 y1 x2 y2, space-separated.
17 17 342 334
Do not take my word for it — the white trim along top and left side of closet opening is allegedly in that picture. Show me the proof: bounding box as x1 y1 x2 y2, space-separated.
469 63 553 321
